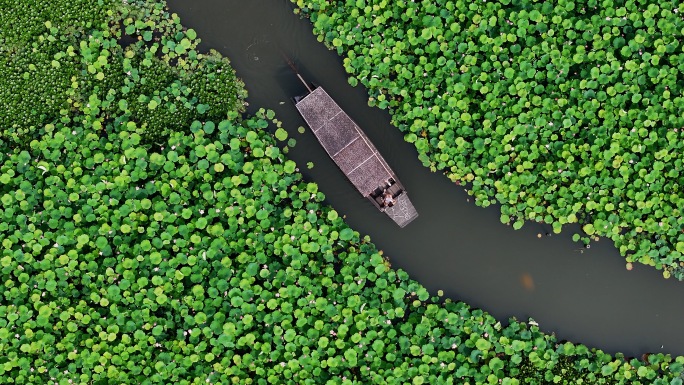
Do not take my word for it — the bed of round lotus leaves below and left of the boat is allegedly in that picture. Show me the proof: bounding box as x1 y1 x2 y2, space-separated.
0 3 684 385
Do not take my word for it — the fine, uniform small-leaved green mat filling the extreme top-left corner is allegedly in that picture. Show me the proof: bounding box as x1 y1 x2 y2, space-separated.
0 0 115 138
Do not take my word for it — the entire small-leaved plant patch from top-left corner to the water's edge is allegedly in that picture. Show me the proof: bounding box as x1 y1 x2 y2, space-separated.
0 1 245 145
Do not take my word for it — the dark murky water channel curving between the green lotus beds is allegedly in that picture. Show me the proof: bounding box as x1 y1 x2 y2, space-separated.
168 0 684 356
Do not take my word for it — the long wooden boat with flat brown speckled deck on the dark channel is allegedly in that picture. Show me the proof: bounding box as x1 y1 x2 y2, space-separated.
293 83 418 227
